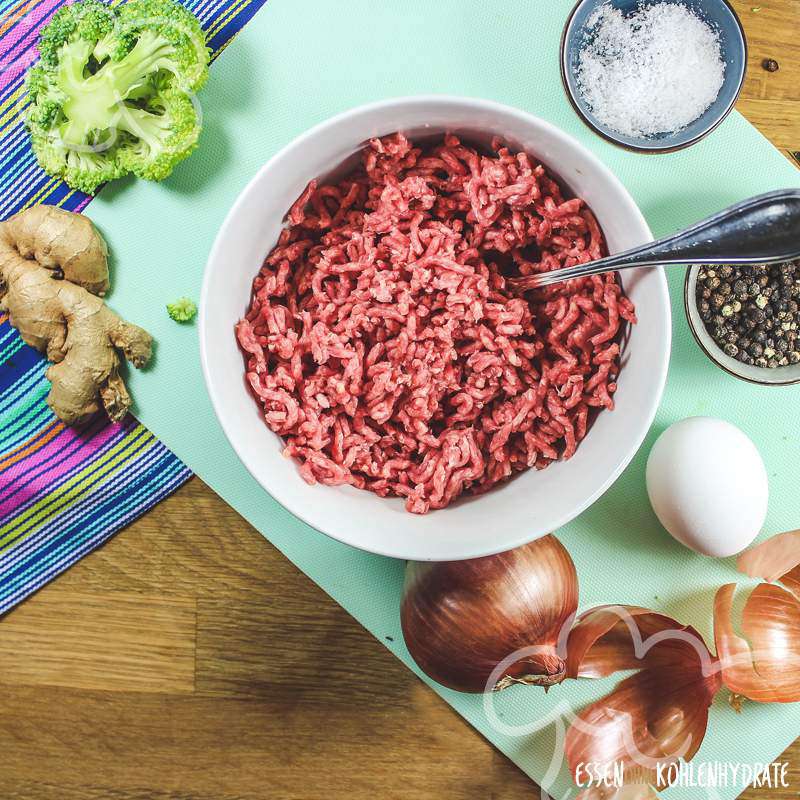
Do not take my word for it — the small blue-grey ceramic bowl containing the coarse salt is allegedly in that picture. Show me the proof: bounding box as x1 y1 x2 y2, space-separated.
561 0 747 153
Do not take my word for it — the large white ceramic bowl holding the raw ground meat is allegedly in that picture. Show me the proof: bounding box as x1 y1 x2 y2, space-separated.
199 96 671 560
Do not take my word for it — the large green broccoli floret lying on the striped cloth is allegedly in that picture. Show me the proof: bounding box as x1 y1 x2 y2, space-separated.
26 0 208 194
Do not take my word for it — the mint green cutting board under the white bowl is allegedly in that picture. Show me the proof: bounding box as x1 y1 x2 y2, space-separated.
89 0 800 800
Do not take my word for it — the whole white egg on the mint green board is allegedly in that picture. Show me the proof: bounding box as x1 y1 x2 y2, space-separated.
647 417 769 557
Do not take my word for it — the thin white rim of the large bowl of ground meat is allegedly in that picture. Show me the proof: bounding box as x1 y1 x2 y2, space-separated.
202 94 672 561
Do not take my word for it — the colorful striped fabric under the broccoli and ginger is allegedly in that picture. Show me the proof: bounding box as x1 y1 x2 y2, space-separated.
0 0 265 614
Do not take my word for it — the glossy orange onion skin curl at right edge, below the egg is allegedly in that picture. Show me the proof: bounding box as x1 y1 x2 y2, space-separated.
714 570 800 703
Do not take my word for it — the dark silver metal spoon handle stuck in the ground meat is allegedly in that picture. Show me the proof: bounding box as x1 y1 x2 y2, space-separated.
507 189 800 293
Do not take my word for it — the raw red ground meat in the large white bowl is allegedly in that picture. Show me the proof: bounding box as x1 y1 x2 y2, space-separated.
236 134 635 514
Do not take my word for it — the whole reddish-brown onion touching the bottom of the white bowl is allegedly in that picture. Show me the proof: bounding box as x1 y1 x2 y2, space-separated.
401 534 578 692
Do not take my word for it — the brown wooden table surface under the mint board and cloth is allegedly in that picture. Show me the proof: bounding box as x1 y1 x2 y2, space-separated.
0 0 800 800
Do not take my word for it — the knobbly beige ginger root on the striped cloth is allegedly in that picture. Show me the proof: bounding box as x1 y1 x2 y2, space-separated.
0 205 152 425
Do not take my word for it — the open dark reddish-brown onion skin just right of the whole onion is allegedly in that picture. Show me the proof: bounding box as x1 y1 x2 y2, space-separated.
564 606 721 796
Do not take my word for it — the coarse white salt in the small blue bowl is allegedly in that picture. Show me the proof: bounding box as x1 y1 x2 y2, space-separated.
576 3 725 137
